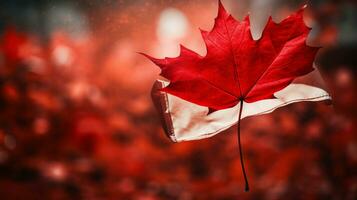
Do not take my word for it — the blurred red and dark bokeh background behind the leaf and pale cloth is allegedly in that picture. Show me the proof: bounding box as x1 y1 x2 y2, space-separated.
0 0 357 200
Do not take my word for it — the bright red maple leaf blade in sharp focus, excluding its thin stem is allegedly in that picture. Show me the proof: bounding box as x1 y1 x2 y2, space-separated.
143 2 318 110
